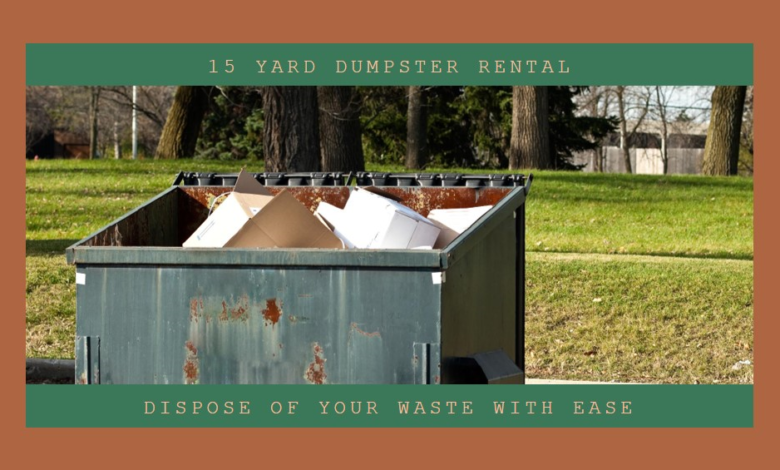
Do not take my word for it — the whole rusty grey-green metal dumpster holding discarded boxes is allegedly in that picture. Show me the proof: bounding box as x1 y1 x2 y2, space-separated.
67 171 532 384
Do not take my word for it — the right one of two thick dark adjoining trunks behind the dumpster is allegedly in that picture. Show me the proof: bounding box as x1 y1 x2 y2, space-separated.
317 86 365 172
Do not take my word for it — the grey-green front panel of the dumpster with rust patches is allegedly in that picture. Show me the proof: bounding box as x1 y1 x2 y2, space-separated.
77 265 441 384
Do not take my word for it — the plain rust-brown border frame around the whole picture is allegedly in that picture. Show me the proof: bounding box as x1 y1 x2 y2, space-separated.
7 0 779 468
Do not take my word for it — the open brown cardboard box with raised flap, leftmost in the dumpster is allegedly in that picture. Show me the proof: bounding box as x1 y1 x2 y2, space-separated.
183 171 343 248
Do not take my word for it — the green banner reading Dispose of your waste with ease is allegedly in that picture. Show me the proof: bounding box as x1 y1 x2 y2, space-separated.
26 385 753 428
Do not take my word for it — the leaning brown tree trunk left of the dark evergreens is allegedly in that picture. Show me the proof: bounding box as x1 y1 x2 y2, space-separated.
154 86 213 159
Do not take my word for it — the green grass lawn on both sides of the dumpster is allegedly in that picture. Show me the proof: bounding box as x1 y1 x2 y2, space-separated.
26 160 753 383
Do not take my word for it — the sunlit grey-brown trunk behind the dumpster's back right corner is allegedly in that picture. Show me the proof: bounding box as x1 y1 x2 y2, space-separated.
509 86 552 170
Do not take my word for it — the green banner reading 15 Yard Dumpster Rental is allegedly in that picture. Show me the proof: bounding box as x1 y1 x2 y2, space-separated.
27 44 753 86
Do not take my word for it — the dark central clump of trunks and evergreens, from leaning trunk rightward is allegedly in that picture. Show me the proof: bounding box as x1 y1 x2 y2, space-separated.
155 86 616 171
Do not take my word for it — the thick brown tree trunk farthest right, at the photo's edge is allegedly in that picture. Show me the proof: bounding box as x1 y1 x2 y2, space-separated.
702 86 747 175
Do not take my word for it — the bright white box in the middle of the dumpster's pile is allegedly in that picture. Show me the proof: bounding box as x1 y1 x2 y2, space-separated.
317 188 440 249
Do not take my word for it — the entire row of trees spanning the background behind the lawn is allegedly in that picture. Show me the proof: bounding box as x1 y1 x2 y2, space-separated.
27 86 753 174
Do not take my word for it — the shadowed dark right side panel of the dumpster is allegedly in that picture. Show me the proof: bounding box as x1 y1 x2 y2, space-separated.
441 212 518 383
